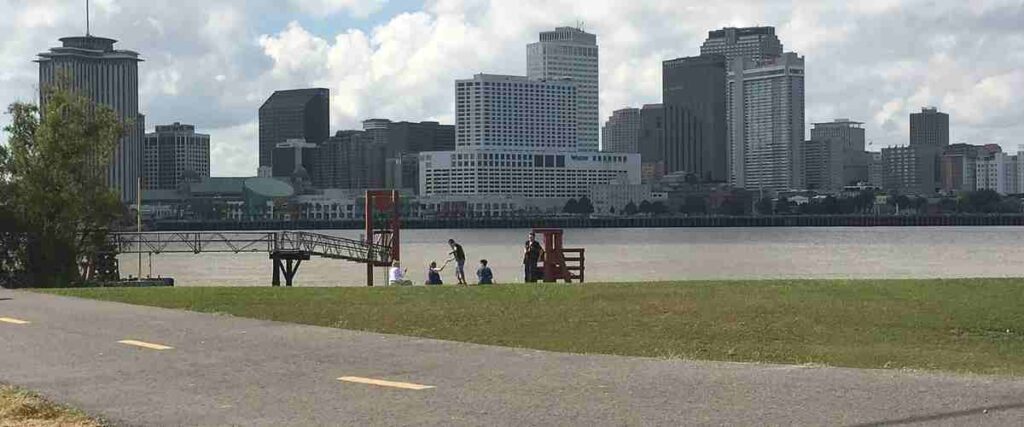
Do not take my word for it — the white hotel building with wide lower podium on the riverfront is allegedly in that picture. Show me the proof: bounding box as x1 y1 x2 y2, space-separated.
420 74 640 200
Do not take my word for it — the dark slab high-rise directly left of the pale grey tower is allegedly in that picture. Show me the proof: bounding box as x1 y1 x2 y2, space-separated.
662 53 728 182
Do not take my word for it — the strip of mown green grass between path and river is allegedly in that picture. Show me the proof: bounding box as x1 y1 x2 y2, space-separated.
41 279 1024 376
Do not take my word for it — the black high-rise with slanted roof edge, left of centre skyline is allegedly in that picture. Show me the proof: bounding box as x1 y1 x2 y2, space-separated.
259 88 331 167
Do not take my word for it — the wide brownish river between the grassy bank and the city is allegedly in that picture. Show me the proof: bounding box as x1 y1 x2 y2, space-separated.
120 226 1024 286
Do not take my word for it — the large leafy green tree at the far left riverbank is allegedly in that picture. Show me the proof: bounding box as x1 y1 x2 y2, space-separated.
0 83 126 287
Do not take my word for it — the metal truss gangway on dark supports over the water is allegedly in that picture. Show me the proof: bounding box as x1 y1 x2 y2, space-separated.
110 231 394 286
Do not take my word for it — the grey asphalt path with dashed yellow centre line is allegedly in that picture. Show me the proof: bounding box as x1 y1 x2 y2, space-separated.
0 290 1024 426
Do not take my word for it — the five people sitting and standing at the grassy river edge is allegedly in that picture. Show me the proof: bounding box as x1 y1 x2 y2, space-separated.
388 232 544 286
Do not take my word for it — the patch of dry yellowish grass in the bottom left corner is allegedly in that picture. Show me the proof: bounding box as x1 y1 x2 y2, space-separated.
0 385 102 427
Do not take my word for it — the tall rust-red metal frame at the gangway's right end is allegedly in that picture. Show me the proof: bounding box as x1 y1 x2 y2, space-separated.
364 189 401 287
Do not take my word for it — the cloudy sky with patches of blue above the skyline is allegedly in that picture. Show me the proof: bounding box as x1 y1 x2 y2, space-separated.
0 0 1024 175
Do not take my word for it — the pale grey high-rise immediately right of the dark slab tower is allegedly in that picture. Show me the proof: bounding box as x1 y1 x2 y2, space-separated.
726 52 804 191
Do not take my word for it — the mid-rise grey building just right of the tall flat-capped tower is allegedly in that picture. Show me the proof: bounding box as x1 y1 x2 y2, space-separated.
142 122 210 189
